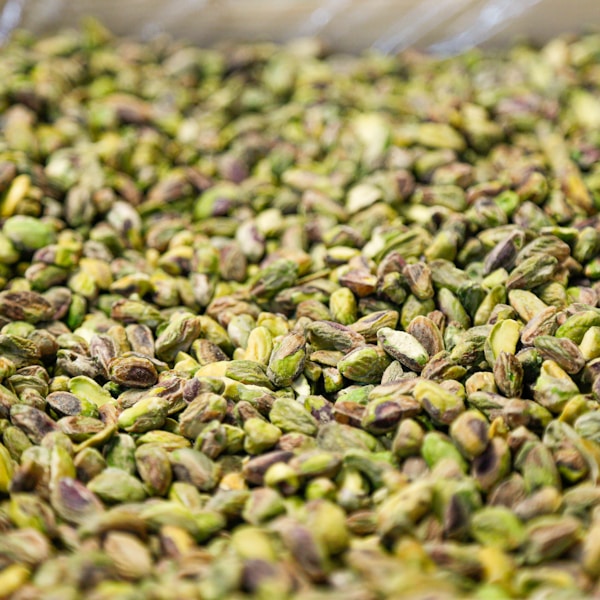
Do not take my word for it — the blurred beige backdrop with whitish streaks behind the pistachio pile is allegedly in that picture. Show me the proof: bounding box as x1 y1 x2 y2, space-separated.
0 0 600 54
